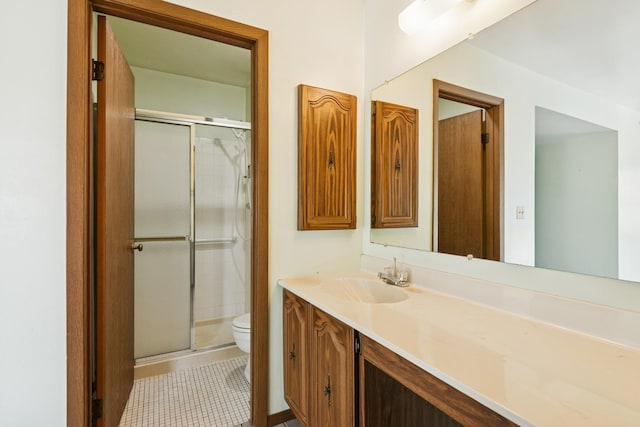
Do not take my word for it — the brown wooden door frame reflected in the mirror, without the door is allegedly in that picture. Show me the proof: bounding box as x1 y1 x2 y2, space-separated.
432 79 504 260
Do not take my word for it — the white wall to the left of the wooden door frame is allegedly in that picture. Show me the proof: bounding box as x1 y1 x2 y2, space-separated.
0 0 67 426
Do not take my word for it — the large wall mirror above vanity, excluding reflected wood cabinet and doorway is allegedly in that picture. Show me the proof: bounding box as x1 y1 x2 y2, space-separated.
371 0 640 281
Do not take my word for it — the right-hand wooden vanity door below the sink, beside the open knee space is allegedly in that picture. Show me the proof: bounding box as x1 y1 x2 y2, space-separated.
309 307 355 427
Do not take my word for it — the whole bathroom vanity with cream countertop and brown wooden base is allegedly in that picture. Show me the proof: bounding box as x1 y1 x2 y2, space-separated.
279 273 640 427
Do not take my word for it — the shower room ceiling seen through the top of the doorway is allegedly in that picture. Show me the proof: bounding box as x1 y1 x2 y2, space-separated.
108 16 251 87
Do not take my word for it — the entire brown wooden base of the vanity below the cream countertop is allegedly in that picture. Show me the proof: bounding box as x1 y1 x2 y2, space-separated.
283 289 516 427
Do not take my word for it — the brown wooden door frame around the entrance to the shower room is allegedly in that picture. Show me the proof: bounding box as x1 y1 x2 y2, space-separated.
66 0 269 427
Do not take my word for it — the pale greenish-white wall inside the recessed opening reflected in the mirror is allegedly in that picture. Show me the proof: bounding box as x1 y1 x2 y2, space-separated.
535 131 618 278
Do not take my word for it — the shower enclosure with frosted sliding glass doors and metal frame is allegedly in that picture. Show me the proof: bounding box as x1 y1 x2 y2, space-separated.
134 110 251 360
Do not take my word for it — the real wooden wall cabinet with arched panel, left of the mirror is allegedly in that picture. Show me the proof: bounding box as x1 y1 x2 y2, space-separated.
298 85 357 230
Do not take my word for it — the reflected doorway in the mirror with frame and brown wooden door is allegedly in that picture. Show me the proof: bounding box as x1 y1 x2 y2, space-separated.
433 79 504 261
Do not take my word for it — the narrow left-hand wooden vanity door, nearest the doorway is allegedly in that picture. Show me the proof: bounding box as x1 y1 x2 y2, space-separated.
283 289 309 425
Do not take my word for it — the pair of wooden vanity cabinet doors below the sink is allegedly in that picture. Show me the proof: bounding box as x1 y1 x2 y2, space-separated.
283 290 355 427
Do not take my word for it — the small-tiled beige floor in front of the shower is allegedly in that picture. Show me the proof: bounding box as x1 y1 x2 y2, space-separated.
120 356 249 427
